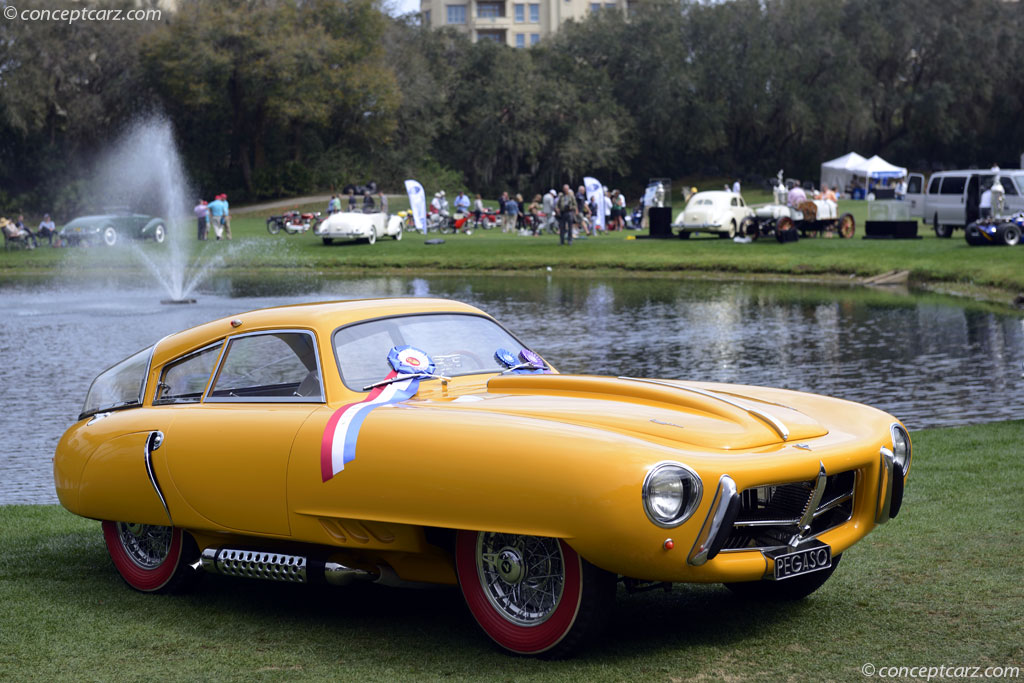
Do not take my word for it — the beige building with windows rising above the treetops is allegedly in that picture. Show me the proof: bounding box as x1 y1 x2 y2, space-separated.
420 0 631 47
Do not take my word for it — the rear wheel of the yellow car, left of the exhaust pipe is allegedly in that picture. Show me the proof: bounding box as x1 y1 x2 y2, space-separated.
103 521 200 593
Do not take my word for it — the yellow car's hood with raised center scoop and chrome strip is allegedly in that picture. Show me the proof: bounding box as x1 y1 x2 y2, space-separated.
419 375 828 451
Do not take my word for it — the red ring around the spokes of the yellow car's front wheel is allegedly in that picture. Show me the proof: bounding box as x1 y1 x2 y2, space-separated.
456 531 583 654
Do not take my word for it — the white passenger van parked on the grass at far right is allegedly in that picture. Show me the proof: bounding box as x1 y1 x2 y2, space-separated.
906 169 1024 238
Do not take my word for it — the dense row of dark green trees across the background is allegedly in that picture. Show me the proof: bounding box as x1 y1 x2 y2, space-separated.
0 0 1024 211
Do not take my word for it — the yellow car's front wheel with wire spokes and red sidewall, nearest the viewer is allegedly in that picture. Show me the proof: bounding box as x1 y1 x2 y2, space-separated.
456 531 616 657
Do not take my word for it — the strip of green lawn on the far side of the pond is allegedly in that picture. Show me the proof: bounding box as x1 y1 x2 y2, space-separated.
0 193 1024 301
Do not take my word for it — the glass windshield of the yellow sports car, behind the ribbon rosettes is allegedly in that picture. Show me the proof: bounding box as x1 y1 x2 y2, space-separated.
334 313 523 391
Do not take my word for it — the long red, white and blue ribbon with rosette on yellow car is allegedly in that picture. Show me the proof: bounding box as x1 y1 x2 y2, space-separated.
321 346 434 481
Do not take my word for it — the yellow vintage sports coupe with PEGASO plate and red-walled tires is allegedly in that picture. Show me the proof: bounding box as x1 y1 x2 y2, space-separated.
53 299 910 656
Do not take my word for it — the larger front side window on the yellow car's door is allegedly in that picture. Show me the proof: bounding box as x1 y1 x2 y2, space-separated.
206 332 324 402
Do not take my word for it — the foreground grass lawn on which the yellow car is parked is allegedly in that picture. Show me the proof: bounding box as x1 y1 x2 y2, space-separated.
0 421 1024 681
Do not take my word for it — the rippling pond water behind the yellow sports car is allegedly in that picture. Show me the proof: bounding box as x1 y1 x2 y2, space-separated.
0 274 1024 504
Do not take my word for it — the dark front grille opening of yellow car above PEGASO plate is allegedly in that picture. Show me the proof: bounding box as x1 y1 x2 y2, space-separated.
722 470 857 551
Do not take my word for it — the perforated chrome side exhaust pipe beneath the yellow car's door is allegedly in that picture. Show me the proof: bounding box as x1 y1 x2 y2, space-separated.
200 548 380 586
